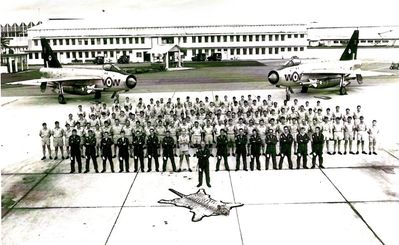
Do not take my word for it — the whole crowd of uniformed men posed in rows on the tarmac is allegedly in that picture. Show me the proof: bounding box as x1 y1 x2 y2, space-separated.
40 95 378 178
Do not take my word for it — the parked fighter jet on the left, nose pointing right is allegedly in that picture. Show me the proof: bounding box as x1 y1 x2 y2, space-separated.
10 38 137 104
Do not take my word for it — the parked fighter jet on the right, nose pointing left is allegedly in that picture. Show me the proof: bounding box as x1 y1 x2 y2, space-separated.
267 30 367 100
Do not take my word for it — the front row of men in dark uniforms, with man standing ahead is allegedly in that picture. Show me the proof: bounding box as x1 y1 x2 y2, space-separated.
68 127 324 177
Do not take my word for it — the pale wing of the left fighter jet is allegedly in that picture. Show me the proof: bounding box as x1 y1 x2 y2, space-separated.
8 76 102 87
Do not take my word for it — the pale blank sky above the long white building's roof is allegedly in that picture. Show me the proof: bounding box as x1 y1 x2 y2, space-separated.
0 0 399 26
